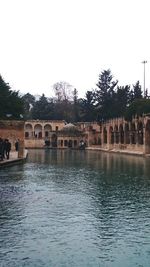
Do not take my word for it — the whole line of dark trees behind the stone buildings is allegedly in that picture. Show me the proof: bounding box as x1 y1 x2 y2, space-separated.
0 69 150 122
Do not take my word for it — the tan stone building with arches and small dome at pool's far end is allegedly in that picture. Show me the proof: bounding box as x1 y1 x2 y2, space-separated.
25 120 100 149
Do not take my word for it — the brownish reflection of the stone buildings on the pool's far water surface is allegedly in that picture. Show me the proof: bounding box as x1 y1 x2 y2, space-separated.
29 149 150 176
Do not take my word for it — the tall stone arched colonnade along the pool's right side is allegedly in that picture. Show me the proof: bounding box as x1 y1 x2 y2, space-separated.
100 117 150 153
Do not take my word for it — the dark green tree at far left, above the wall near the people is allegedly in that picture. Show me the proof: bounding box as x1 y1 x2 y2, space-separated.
0 75 24 119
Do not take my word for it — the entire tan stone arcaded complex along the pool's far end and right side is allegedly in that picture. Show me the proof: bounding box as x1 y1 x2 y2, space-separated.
25 115 150 154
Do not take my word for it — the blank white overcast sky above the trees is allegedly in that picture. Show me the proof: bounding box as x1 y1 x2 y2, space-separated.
0 0 150 97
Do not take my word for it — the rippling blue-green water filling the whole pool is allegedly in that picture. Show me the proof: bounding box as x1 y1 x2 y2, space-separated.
0 150 150 267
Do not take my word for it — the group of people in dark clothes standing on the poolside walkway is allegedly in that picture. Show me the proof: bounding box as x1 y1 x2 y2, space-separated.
0 138 11 161
